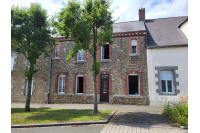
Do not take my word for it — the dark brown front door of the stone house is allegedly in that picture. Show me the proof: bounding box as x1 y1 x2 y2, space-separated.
100 74 109 102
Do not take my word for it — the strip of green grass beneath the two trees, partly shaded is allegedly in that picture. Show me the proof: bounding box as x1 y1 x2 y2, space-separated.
11 108 112 125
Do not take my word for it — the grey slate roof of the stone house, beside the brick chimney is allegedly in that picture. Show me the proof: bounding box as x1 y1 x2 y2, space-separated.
113 21 146 34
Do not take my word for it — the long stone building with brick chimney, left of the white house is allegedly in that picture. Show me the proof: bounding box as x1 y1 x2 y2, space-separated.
11 9 149 105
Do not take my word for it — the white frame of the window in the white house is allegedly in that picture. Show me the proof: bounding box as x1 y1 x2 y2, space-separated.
160 70 174 94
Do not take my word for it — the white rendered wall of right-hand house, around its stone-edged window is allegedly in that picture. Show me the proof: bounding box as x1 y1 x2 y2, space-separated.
147 47 188 106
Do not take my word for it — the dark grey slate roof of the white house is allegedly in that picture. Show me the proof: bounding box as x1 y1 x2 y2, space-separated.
145 16 188 48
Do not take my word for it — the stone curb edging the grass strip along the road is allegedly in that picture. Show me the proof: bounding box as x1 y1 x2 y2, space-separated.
11 111 116 128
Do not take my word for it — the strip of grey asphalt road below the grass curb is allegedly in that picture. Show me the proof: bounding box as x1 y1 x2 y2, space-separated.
11 125 105 133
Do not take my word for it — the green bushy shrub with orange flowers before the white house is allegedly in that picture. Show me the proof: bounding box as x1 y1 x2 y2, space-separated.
162 101 188 126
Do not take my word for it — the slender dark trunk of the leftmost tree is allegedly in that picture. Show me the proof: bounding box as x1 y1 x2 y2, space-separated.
25 63 34 112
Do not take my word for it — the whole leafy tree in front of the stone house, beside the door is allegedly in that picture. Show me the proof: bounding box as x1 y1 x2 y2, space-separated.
54 0 114 114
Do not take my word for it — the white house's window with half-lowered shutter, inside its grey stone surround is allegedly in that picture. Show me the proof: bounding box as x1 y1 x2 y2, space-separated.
160 71 173 93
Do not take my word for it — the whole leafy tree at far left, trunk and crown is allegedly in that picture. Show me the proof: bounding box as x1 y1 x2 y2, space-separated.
11 3 55 112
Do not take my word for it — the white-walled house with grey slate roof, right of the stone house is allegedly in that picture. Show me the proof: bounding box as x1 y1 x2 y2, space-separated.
145 16 188 105
